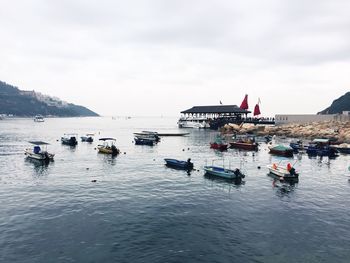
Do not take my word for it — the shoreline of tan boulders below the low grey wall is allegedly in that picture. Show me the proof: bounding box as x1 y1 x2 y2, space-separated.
221 121 350 143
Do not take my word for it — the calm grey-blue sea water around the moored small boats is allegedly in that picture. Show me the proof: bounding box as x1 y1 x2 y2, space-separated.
0 117 350 263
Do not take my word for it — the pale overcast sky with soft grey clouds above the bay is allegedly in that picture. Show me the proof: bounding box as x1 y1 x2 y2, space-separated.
0 0 350 116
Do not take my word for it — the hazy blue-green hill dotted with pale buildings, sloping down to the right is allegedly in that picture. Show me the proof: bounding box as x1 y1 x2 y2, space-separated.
0 81 99 117
